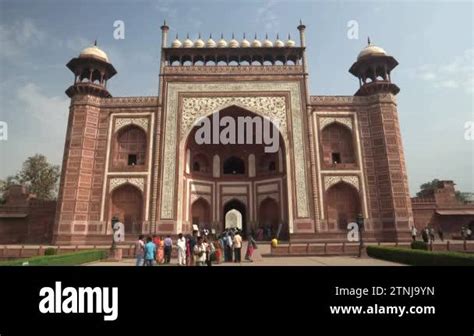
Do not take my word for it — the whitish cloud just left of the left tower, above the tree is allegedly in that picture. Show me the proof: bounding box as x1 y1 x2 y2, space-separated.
17 83 69 134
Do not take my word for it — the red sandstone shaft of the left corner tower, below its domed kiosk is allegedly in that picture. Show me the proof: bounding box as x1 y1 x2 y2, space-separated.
56 96 108 240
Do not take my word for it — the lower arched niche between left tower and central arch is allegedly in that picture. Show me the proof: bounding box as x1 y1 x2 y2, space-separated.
110 184 143 234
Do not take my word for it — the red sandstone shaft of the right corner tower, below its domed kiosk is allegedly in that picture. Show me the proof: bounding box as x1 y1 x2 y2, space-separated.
358 95 412 238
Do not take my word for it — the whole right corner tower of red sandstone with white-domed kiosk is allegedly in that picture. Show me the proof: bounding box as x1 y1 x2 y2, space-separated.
349 39 413 241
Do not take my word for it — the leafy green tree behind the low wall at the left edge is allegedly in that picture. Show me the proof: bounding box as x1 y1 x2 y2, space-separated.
0 154 60 200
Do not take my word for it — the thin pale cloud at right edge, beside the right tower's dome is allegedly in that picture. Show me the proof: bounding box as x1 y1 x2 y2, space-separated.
415 48 474 94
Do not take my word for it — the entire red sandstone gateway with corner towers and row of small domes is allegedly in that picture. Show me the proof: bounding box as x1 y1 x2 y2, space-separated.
54 24 413 244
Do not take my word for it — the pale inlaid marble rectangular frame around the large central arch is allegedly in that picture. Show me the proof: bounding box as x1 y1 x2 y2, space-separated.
160 82 309 233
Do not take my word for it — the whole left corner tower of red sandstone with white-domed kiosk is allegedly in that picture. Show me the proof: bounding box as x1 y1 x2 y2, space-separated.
53 43 117 244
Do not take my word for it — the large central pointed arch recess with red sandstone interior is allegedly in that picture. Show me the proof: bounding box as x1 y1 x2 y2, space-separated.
180 105 291 237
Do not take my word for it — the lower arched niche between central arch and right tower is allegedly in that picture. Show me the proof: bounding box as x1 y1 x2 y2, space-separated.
326 182 361 231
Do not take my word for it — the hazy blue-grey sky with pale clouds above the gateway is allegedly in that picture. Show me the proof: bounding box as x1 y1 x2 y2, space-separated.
0 0 474 195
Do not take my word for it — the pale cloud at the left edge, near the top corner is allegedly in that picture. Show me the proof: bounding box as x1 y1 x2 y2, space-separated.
0 18 47 61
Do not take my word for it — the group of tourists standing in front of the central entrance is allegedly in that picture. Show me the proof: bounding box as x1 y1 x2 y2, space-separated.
135 228 257 266
